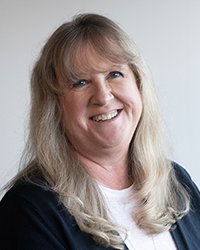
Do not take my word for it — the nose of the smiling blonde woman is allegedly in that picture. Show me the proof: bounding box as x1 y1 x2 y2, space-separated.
90 79 114 106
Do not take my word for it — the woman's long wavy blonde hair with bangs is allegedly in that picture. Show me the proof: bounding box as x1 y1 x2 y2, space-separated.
9 14 189 249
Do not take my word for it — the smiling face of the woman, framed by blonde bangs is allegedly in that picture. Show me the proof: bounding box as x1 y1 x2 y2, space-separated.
60 52 142 157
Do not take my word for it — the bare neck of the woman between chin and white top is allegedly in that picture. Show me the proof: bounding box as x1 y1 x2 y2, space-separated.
78 150 132 190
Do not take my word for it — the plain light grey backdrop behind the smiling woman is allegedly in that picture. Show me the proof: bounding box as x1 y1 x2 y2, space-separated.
0 0 200 193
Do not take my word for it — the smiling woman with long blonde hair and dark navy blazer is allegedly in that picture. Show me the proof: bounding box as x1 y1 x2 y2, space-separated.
0 14 200 250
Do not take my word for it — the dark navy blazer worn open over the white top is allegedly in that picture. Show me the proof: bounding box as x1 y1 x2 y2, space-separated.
0 164 200 250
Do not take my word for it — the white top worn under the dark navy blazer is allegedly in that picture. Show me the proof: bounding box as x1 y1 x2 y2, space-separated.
98 184 177 250
